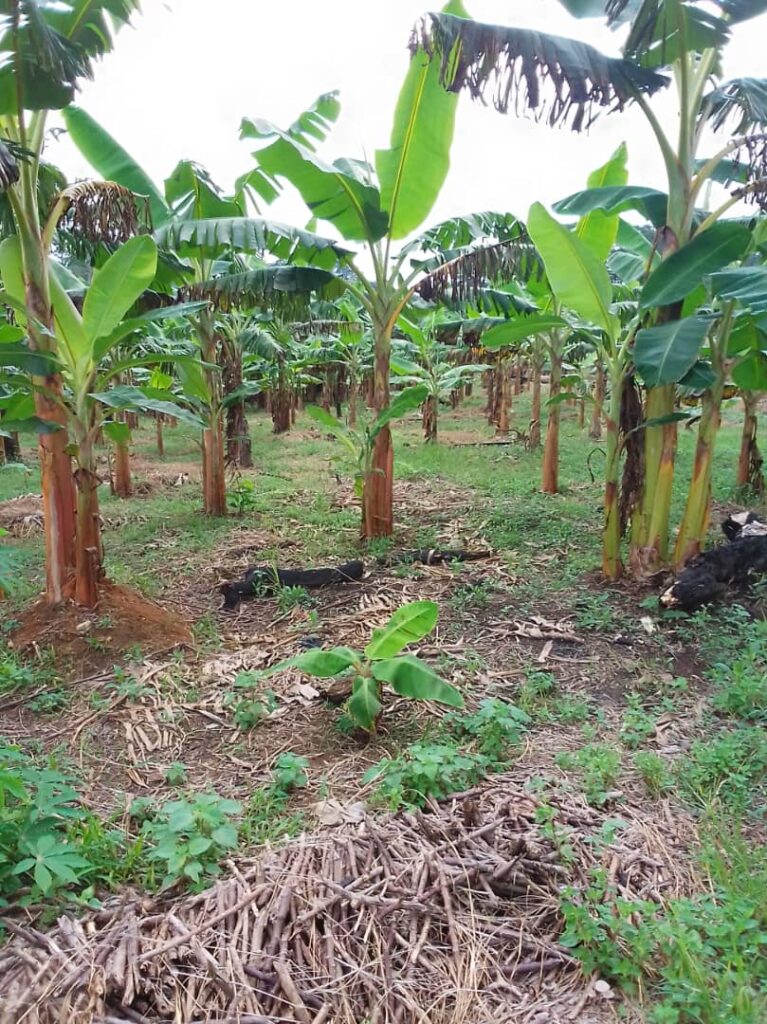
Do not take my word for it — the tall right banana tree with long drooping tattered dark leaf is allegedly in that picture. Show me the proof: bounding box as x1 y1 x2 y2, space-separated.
414 0 767 570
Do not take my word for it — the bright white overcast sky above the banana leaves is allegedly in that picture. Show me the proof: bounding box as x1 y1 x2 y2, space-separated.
49 0 767 240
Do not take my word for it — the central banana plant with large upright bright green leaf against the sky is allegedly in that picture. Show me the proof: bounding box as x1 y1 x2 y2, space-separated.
241 0 532 537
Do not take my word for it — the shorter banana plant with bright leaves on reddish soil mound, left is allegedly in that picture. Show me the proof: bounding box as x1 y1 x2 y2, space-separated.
0 234 200 607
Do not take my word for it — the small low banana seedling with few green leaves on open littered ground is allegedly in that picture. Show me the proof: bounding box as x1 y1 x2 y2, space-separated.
258 601 463 733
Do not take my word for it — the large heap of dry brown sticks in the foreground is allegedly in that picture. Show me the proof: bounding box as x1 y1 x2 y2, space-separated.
0 776 684 1024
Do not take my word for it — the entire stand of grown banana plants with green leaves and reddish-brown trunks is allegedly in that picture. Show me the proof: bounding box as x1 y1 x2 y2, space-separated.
0 0 767 606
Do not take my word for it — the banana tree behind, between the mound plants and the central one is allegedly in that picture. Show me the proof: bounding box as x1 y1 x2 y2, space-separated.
63 105 347 515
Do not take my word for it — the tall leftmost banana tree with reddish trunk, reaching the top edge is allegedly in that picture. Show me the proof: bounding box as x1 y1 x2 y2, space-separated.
0 0 138 603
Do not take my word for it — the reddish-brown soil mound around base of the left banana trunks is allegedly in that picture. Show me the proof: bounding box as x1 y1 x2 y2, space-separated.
11 583 191 668
